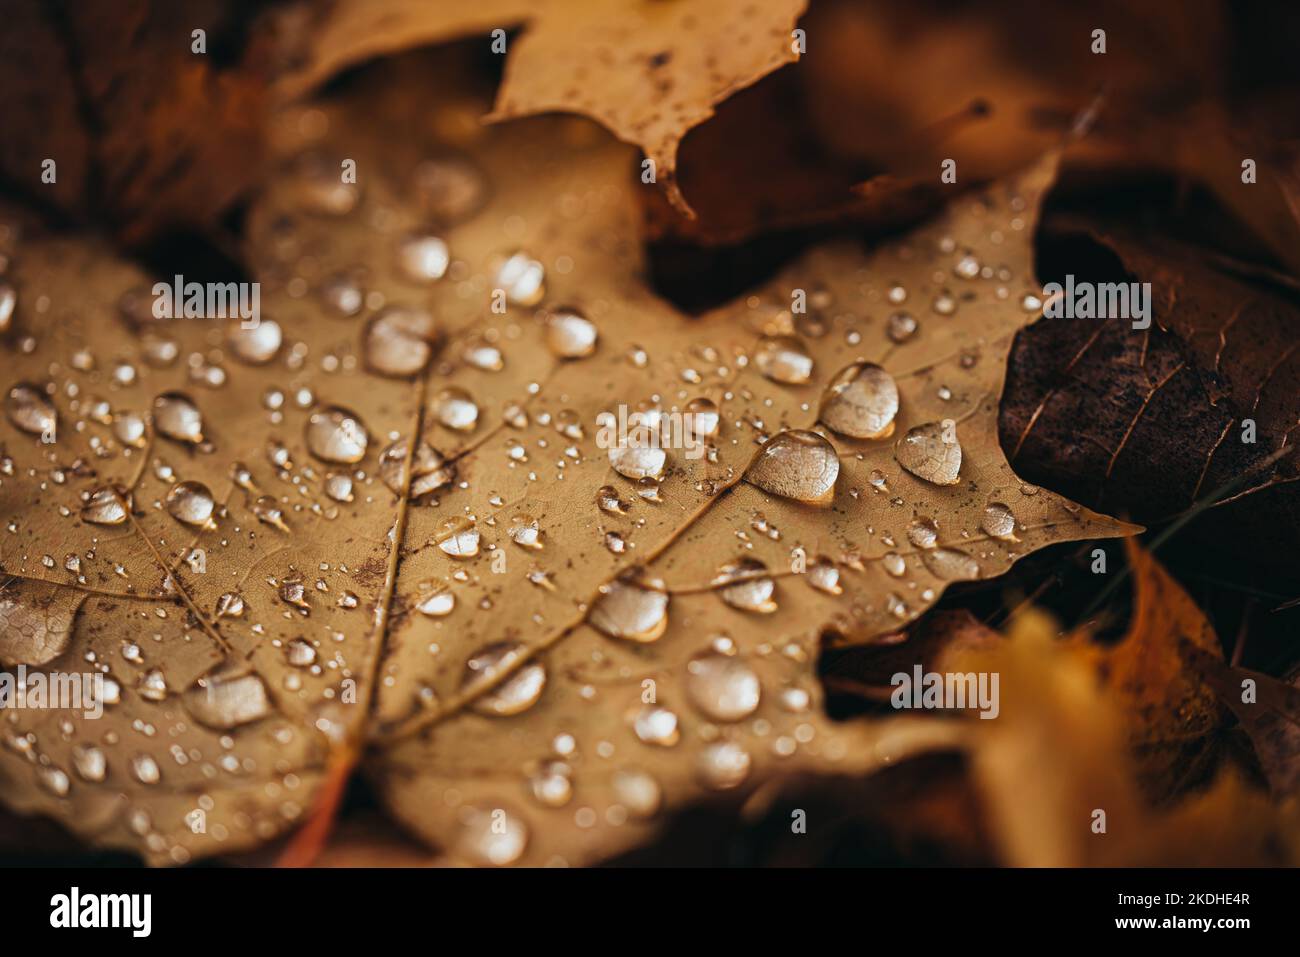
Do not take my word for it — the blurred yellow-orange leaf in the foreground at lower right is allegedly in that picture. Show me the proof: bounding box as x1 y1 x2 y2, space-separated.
945 611 1300 867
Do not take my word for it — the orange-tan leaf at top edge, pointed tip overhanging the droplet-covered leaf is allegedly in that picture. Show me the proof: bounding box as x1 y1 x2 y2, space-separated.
271 0 807 215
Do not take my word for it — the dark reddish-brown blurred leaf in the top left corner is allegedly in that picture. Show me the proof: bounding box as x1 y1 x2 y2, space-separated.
0 0 273 243
